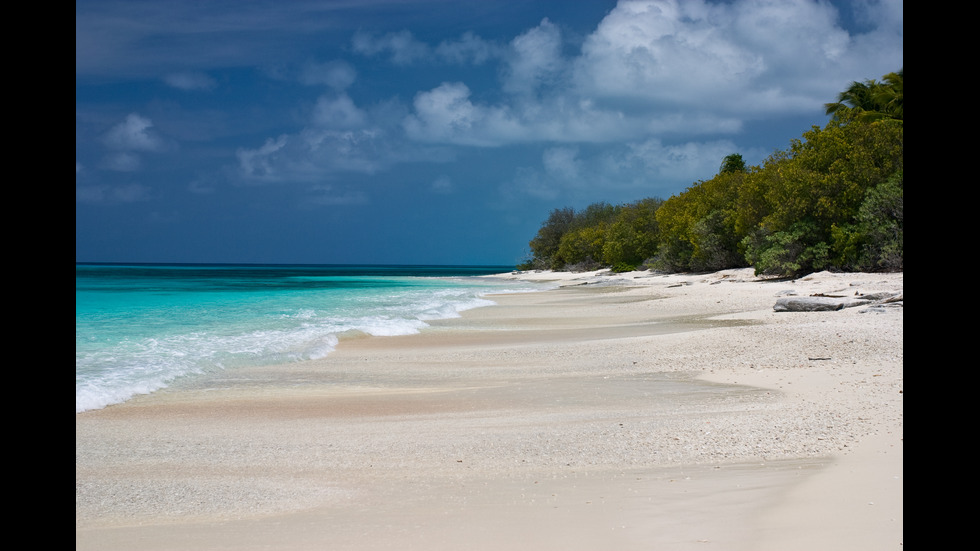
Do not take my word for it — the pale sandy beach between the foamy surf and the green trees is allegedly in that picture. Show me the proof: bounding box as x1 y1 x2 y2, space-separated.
75 270 904 551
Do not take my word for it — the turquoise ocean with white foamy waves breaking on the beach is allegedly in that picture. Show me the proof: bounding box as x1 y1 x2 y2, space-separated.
75 263 542 413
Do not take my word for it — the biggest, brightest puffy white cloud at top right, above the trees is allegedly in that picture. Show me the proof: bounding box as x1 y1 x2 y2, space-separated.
574 0 902 118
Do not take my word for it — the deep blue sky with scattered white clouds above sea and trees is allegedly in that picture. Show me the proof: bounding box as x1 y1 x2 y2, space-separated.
75 0 903 265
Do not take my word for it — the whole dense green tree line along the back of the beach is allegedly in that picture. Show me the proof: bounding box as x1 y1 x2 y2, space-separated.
518 70 904 276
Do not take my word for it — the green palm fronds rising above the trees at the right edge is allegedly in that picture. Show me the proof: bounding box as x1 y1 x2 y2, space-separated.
824 68 905 122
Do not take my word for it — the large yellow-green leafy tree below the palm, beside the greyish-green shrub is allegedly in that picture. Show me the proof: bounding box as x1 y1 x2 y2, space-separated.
736 120 904 275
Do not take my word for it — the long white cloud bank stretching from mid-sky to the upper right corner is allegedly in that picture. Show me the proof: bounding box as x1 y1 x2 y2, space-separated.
404 0 901 146
